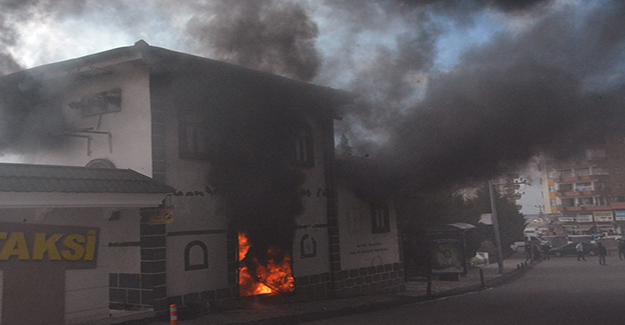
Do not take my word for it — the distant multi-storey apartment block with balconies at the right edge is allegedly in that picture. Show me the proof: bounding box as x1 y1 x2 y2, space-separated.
539 136 625 235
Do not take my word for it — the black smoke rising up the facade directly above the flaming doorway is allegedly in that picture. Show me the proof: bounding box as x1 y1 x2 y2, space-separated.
209 103 306 266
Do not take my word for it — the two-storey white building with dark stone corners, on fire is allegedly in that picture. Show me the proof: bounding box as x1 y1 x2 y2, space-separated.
0 41 403 323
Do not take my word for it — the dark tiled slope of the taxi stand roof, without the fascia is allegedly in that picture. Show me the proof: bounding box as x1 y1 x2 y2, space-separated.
0 163 175 194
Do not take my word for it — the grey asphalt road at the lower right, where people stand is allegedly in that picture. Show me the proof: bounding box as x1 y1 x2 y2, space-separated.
306 256 625 325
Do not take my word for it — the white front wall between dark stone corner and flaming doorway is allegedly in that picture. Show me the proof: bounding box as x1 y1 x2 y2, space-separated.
165 111 228 296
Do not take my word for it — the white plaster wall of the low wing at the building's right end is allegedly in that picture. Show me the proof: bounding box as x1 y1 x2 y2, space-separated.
338 184 399 270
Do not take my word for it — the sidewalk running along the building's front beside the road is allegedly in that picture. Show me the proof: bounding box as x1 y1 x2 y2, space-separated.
141 253 533 325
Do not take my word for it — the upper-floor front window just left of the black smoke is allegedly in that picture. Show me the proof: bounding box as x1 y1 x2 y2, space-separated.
178 113 214 160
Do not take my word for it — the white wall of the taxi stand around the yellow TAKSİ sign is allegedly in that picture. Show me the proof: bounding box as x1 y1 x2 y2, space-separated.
0 208 140 324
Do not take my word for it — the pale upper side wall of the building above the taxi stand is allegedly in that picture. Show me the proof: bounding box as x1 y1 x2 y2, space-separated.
14 63 152 177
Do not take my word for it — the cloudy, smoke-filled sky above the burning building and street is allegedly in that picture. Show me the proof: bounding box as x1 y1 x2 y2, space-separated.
0 0 625 213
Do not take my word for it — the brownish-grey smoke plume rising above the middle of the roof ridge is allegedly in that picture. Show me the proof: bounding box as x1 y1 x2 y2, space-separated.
187 0 321 81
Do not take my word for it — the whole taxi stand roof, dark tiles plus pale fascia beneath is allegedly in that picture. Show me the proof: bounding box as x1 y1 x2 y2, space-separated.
0 163 175 208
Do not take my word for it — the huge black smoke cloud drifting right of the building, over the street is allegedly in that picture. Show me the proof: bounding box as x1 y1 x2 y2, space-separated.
330 1 625 196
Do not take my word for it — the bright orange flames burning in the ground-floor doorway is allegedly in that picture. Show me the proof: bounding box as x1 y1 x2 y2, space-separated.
239 233 295 297
